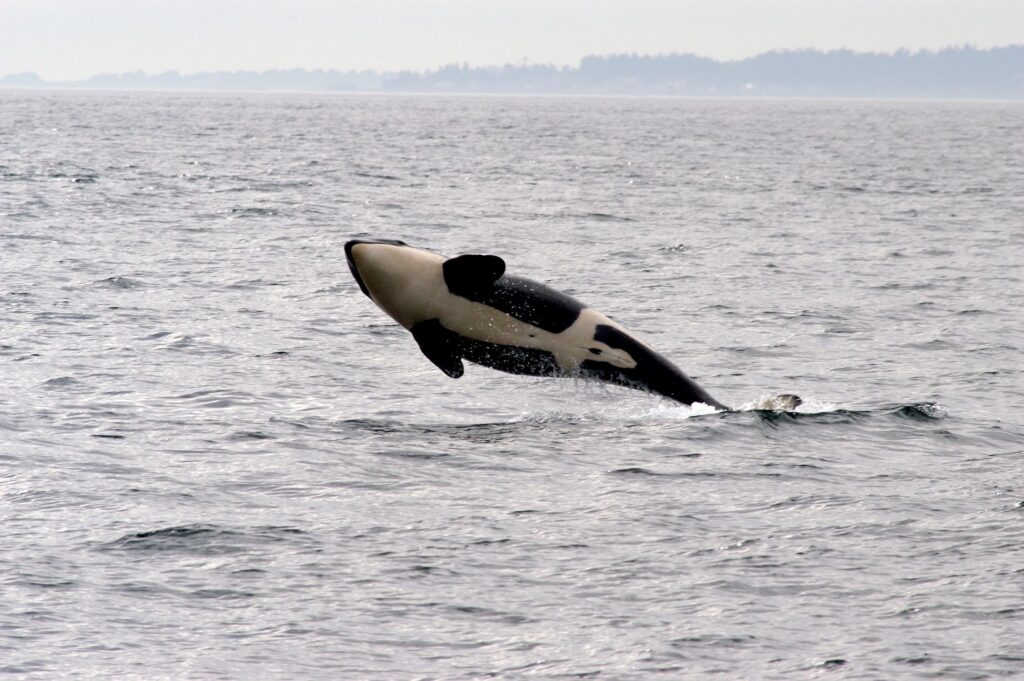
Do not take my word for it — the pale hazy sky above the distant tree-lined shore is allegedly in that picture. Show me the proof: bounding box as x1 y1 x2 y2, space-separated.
0 0 1024 80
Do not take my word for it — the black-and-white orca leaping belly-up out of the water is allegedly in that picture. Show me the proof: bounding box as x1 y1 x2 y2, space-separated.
345 240 728 411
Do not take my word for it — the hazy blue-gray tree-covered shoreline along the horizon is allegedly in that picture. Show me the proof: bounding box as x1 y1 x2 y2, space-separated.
0 45 1024 101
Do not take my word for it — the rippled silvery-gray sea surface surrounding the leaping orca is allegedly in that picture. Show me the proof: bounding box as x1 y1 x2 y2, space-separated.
0 91 1024 679
